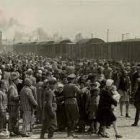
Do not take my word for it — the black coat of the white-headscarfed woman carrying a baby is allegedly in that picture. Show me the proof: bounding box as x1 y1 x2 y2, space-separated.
97 89 117 126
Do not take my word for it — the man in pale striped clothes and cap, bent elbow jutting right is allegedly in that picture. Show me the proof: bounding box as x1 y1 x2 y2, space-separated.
20 78 37 137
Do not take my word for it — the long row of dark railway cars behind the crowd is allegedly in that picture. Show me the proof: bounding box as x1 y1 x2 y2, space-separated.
13 38 140 61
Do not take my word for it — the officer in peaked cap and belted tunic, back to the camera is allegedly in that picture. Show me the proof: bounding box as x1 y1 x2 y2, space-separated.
63 74 80 138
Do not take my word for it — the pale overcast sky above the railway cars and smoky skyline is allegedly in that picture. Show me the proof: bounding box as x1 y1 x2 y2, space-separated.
0 0 140 41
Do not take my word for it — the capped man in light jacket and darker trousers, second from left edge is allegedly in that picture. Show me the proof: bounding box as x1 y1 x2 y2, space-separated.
8 72 20 136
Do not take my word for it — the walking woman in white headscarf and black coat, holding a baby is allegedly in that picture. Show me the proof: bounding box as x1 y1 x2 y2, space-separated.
97 79 118 138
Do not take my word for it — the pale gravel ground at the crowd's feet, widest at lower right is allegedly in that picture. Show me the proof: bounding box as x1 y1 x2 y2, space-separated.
8 105 140 140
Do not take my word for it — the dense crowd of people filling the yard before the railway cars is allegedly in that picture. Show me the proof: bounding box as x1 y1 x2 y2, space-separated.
0 54 140 139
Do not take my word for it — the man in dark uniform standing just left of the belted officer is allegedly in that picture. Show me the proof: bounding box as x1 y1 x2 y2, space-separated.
40 78 57 139
